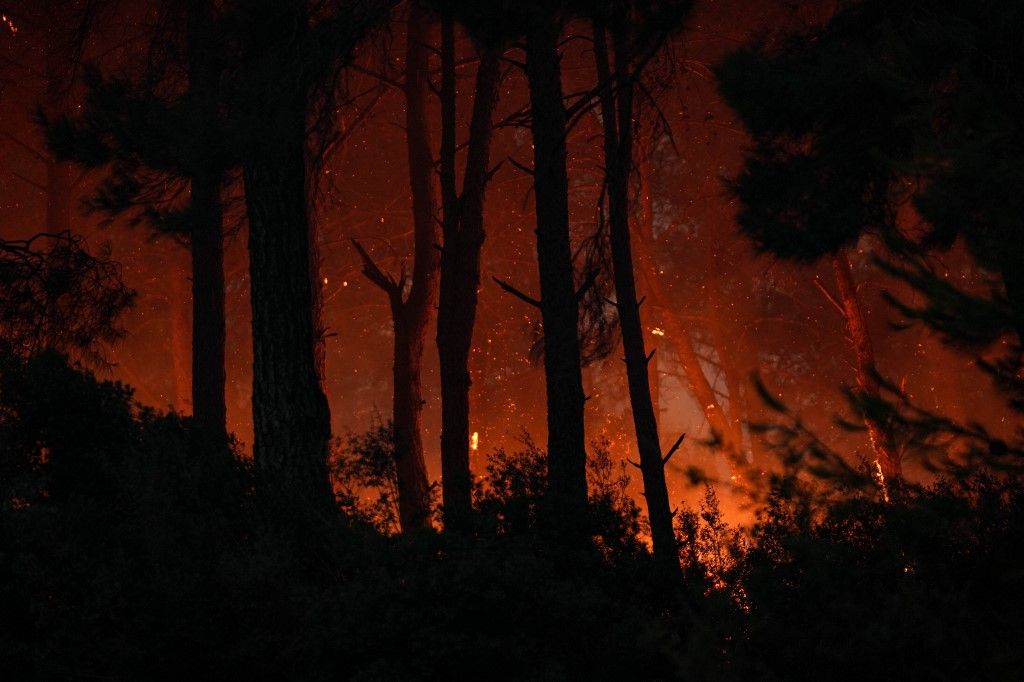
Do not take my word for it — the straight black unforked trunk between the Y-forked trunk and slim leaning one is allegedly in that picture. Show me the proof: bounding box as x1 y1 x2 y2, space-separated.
526 17 587 524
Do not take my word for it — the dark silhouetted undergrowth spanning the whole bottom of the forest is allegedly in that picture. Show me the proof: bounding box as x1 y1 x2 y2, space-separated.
0 354 1024 680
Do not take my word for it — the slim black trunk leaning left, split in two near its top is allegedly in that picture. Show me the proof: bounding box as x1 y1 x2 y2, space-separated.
594 22 681 570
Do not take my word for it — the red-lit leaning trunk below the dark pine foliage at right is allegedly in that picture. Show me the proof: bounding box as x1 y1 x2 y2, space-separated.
833 251 903 481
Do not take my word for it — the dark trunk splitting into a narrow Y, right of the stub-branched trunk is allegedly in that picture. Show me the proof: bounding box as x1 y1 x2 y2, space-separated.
437 17 502 529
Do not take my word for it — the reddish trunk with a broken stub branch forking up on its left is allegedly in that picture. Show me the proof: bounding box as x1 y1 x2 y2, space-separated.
353 9 438 532
